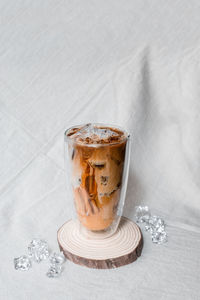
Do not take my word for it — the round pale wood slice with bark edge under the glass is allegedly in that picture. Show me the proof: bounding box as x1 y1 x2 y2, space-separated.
57 217 143 269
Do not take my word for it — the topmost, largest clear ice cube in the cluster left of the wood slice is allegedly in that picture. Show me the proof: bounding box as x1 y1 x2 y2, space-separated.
28 239 49 263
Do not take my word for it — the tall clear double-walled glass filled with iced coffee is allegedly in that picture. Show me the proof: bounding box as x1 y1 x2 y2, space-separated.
65 124 130 239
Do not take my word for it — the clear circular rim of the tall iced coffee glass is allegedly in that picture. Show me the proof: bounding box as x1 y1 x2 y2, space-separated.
64 123 130 147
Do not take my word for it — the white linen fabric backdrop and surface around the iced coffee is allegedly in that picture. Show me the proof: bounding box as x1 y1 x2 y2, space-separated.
0 0 200 300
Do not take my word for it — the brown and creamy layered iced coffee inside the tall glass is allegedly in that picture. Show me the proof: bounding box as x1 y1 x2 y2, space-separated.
68 125 126 231
